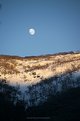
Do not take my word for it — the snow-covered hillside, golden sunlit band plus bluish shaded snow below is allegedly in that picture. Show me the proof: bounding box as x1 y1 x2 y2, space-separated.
0 52 80 105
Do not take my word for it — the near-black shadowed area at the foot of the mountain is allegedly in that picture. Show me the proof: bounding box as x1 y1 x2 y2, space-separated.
0 80 80 121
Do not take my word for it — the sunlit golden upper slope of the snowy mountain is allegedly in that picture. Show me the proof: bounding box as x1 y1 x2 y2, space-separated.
0 53 80 84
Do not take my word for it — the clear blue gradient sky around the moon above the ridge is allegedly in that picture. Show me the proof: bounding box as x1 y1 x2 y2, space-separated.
0 0 80 56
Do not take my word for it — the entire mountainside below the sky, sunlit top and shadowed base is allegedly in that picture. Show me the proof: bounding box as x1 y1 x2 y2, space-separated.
0 52 80 121
